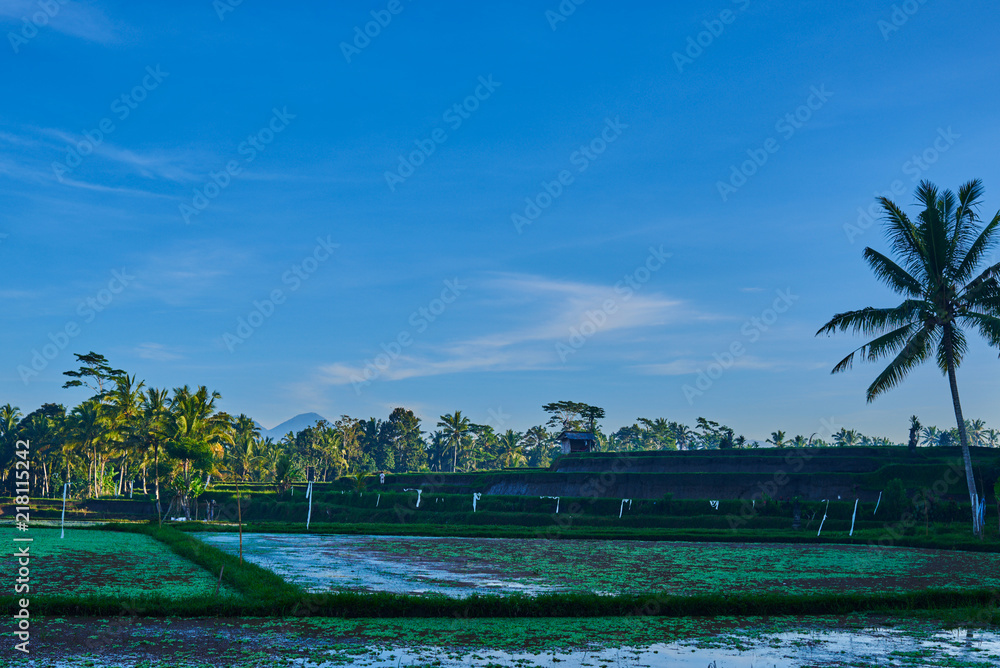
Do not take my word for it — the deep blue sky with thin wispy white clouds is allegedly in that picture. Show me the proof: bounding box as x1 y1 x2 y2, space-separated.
0 0 1000 440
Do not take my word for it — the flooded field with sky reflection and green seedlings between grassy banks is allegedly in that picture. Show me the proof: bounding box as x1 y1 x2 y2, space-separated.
195 533 1000 598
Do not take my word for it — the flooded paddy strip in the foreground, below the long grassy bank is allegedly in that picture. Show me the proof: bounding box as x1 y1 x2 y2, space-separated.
13 617 1000 668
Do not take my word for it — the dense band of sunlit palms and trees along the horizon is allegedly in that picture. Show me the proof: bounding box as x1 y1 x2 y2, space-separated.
0 353 1000 512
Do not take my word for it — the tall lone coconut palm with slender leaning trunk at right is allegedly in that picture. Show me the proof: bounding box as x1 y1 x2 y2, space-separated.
817 179 1000 535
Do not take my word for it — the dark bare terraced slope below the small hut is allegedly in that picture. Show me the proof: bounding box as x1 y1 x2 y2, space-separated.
379 448 1000 502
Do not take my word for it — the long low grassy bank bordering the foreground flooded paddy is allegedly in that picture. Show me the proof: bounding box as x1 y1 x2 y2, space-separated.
13 589 1000 624
